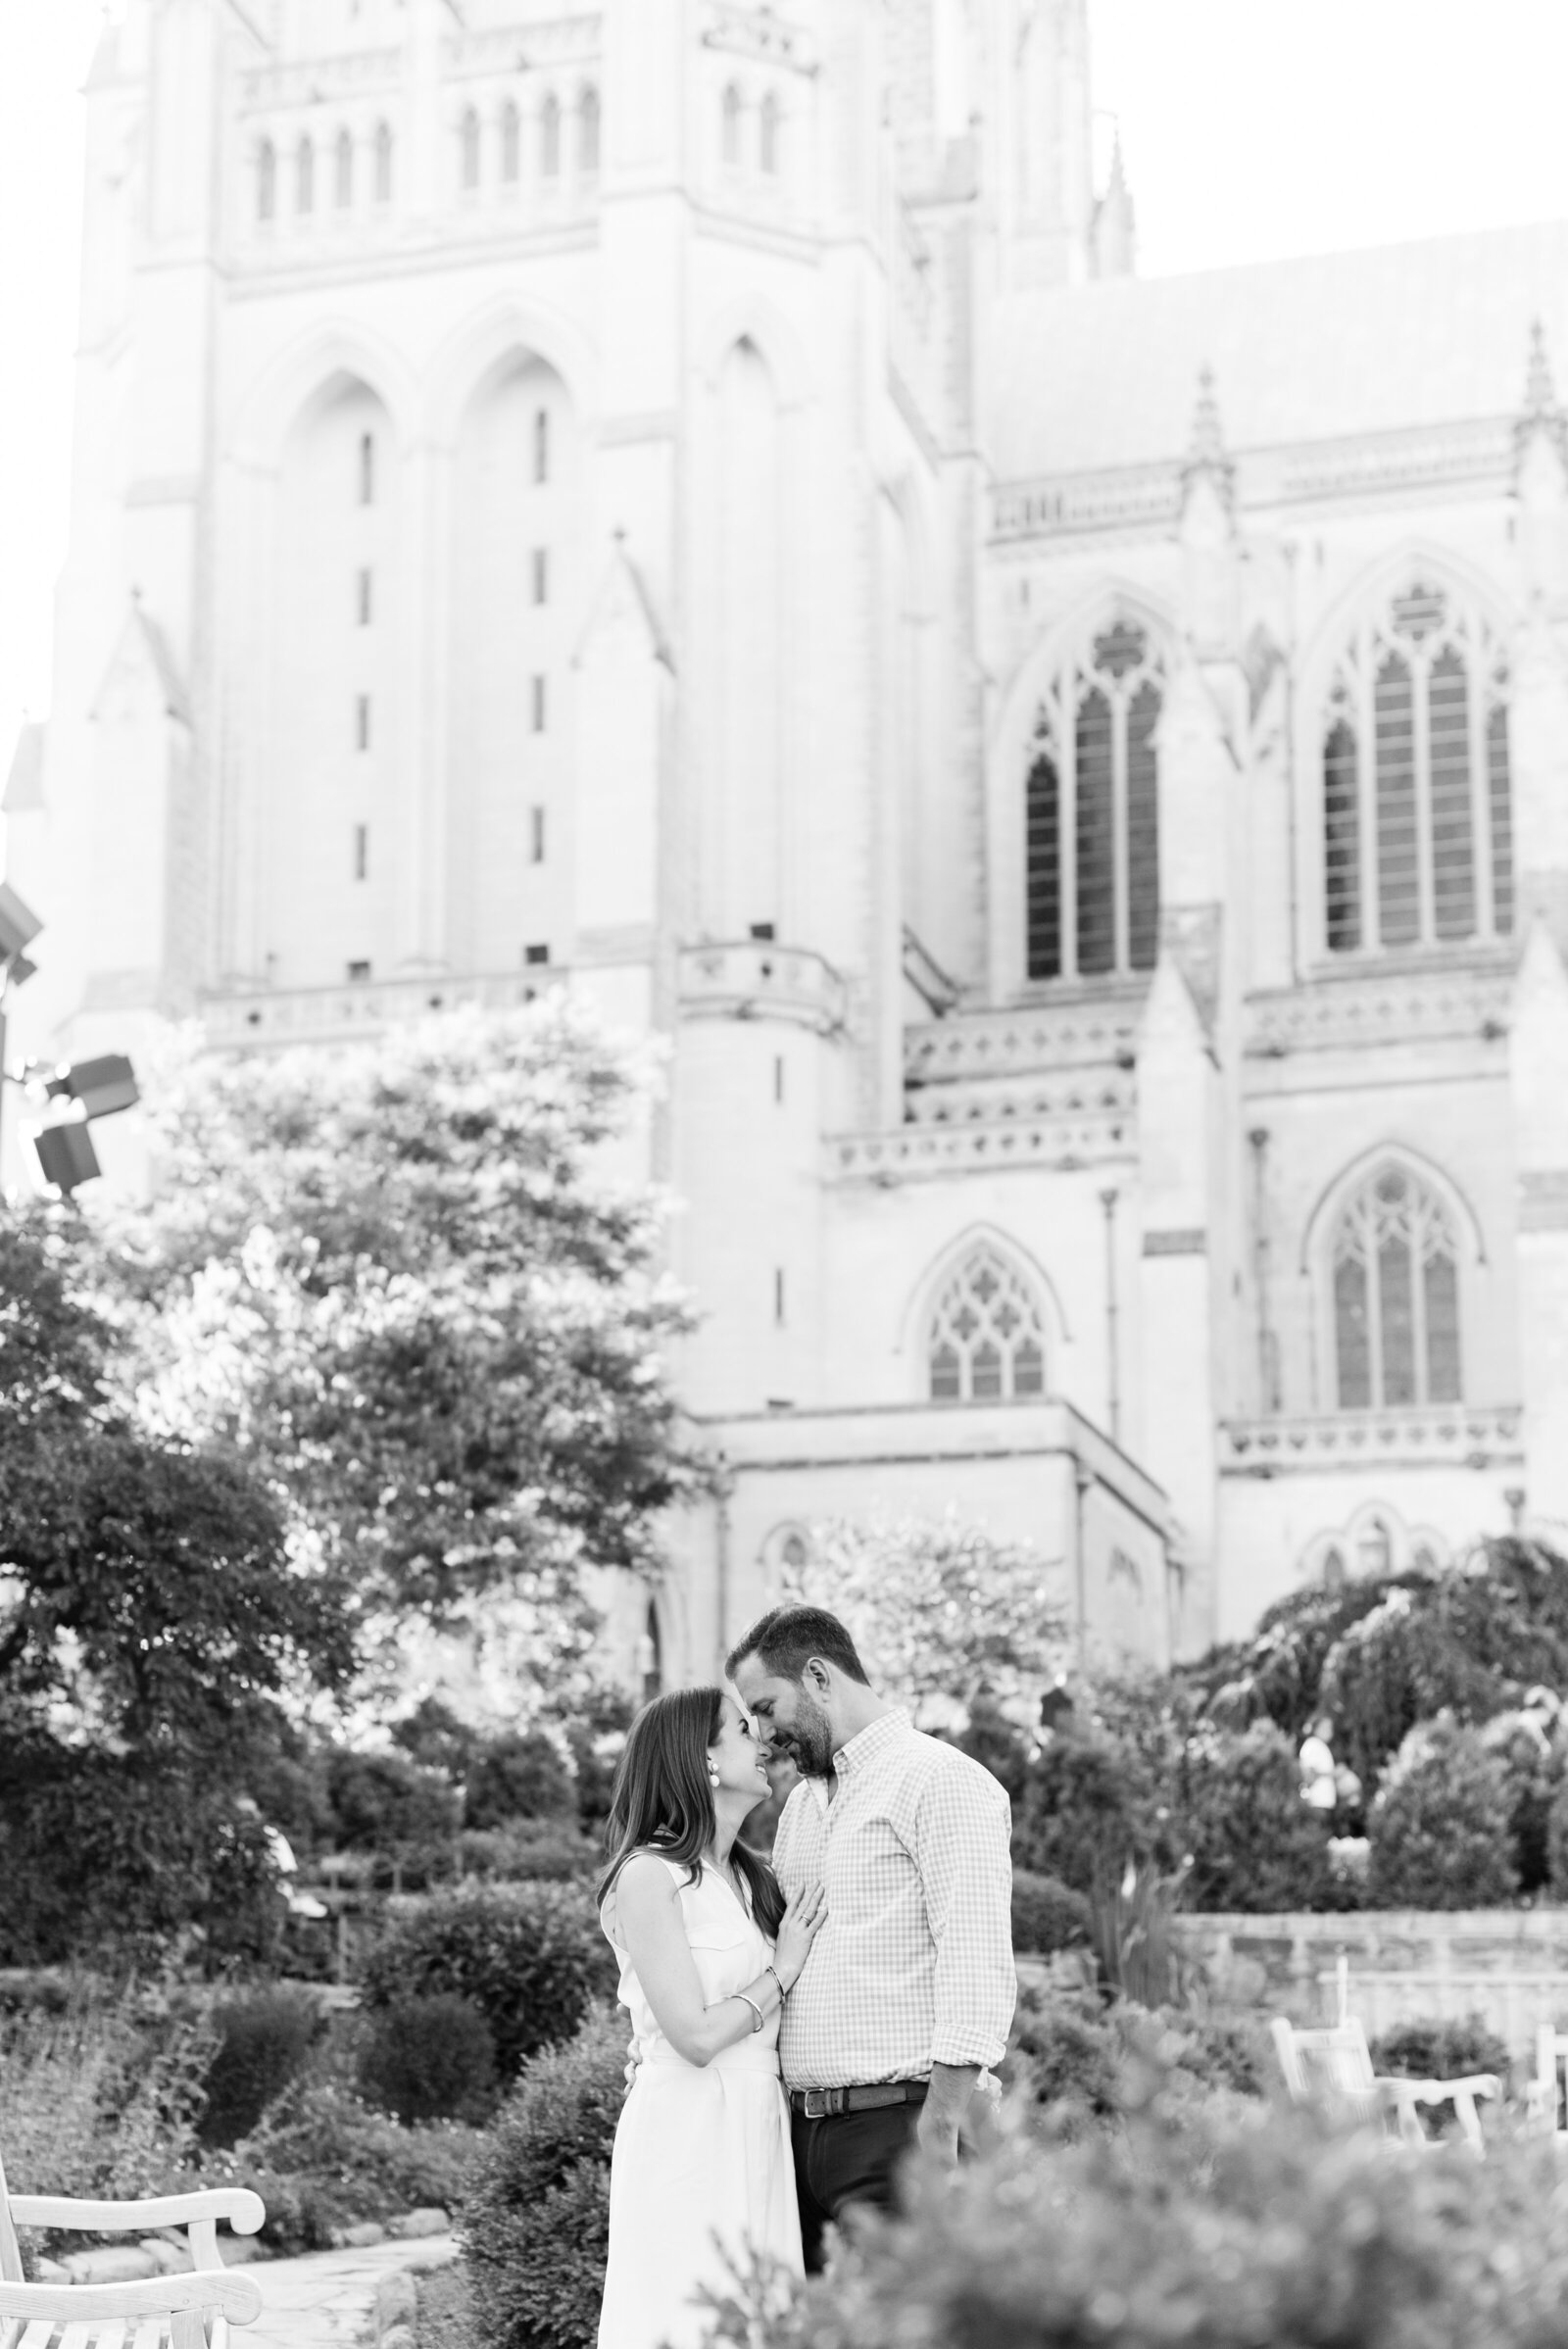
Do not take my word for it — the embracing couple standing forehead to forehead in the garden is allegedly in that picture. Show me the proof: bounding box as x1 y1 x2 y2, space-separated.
599 1607 1016 2349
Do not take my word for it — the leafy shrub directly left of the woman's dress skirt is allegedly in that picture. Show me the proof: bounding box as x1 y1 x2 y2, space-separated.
465 2008 627 2349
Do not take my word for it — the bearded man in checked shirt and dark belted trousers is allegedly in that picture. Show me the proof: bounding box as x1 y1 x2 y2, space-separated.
728 1607 1019 2270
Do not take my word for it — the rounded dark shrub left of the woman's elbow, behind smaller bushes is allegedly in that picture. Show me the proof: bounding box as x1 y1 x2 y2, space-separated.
362 1884 617 2079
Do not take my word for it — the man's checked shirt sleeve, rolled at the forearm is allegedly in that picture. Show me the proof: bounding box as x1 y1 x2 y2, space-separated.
915 1767 1019 2065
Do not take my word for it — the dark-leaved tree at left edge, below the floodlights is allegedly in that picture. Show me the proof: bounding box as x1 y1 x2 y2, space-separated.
0 1221 352 1961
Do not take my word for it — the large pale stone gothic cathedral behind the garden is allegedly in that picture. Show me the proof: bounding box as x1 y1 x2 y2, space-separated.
5 0 1568 1680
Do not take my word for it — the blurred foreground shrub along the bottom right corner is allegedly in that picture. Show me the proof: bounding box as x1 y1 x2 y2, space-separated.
699 2098 1568 2349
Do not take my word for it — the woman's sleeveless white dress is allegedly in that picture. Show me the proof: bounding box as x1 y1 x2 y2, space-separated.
599 1860 803 2349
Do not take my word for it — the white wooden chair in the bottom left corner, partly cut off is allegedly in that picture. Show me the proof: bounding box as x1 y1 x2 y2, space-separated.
0 2168 268 2349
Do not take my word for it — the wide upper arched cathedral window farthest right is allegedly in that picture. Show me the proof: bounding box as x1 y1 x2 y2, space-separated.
1322 585 1514 954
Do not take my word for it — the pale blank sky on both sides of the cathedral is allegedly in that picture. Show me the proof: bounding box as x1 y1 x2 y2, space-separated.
0 0 1568 761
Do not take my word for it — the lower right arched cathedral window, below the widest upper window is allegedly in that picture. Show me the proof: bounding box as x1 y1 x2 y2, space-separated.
1329 1165 1460 1412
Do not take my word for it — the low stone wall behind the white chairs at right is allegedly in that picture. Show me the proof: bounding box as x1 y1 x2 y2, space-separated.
1176 1907 1568 2055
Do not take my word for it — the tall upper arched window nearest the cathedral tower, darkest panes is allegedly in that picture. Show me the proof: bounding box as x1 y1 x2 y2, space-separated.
1023 620 1164 980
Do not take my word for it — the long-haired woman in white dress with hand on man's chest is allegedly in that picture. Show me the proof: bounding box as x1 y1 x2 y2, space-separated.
599 1688 824 2349
